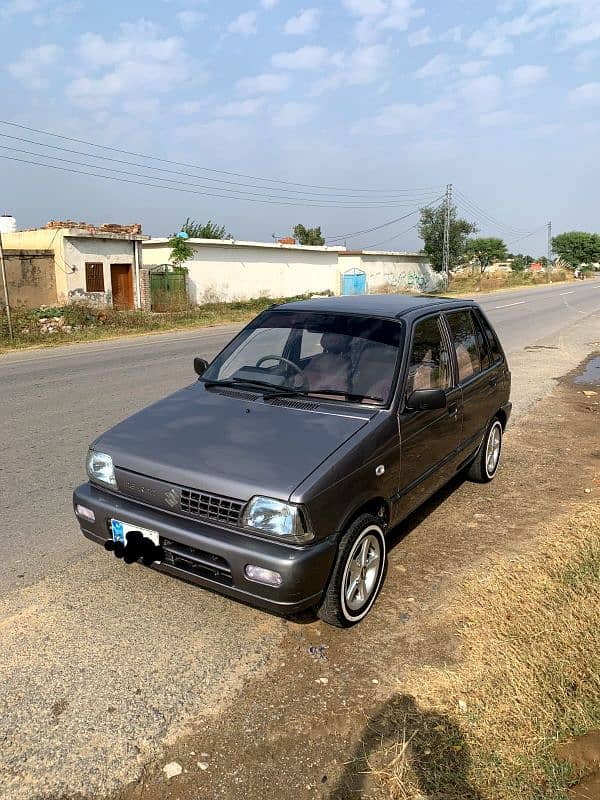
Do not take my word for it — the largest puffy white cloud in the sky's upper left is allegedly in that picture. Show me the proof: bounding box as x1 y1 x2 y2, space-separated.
66 20 195 110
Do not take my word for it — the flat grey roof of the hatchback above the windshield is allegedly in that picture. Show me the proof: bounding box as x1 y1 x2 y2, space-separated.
275 294 473 319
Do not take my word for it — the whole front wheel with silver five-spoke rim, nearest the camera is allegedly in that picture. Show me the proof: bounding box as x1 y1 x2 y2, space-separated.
317 514 387 628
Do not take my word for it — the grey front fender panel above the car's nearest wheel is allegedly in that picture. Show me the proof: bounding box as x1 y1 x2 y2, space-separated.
290 411 400 539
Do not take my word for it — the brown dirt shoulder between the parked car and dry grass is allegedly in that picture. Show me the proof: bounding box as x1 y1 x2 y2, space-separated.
112 358 600 800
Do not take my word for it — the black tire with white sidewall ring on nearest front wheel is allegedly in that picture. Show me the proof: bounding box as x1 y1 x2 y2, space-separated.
317 514 387 628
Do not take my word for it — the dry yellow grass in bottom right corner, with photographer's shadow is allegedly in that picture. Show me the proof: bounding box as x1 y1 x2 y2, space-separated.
364 507 600 800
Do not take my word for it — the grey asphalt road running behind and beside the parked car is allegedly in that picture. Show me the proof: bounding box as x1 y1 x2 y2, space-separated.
0 280 600 800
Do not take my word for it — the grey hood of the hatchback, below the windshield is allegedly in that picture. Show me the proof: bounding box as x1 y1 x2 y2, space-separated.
93 383 377 500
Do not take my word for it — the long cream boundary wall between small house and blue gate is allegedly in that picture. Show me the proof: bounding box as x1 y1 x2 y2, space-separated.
143 240 339 303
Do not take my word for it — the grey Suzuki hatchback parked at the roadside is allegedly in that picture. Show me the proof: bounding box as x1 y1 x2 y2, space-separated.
73 295 511 627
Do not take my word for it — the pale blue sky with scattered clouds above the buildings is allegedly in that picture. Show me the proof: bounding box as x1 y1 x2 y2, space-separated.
0 0 600 255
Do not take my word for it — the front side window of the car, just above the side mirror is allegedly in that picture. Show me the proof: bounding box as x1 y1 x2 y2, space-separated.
406 316 451 397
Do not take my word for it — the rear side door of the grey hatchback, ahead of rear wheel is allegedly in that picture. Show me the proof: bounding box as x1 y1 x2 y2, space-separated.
445 308 500 452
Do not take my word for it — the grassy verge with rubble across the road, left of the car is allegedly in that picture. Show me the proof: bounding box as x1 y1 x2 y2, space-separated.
0 295 308 350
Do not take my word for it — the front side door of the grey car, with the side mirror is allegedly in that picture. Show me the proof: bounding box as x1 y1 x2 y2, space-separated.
398 314 462 516
